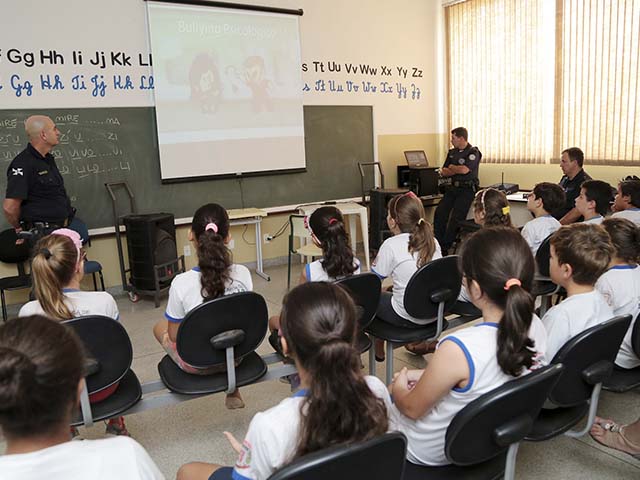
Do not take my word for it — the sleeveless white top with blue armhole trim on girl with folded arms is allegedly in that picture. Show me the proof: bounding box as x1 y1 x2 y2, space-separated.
390 315 546 466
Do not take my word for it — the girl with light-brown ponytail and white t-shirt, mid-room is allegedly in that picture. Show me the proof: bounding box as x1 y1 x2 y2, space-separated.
371 192 442 361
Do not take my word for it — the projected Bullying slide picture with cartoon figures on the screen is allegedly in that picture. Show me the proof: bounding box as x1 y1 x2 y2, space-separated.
152 7 302 132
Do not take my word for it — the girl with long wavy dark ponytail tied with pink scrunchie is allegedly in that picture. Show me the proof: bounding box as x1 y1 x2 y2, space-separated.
153 203 253 409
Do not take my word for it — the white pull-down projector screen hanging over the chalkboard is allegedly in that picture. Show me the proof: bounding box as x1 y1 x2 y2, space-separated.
147 2 305 181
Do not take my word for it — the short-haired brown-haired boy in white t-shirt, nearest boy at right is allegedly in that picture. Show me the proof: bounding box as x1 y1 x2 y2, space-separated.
542 222 613 361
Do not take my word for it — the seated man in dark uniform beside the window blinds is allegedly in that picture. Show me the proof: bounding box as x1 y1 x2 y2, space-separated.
553 147 591 225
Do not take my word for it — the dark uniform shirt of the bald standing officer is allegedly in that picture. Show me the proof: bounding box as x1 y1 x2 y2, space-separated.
6 143 74 228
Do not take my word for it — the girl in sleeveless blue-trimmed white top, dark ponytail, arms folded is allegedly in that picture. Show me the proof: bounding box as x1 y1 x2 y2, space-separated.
389 227 546 465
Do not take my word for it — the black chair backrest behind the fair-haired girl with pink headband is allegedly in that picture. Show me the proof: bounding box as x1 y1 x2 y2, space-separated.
63 315 133 394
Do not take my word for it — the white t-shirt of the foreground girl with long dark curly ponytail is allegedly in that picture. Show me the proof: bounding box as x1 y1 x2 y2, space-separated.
232 376 391 480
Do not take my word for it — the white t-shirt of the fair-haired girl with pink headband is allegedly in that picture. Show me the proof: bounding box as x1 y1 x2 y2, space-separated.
18 288 120 321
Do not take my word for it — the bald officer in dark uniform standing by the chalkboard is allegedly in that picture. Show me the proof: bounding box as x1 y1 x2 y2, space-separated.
2 115 75 238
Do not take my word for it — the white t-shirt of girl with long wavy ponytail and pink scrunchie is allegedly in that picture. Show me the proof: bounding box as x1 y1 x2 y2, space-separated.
164 264 253 323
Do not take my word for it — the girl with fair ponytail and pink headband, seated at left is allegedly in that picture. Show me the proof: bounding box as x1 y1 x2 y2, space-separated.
18 228 129 435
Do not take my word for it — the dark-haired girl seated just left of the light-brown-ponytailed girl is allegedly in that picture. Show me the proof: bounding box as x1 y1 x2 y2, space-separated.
269 206 360 335
